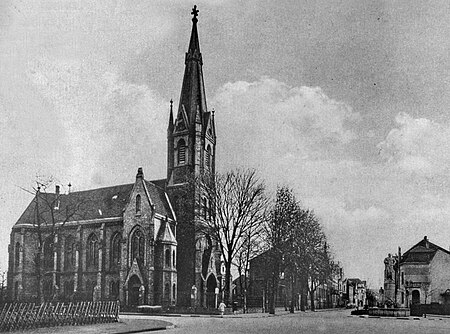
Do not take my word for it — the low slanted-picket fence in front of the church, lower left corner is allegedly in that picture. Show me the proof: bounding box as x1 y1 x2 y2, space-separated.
0 301 119 332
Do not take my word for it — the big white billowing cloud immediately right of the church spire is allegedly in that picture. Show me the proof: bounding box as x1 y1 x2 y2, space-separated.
214 78 360 174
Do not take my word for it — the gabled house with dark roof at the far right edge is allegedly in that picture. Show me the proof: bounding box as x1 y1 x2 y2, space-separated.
397 236 450 307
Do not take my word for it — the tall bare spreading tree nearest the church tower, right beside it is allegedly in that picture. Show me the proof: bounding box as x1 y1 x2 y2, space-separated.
199 170 268 304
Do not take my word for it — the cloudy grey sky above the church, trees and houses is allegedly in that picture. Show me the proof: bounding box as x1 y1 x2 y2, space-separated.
0 0 450 288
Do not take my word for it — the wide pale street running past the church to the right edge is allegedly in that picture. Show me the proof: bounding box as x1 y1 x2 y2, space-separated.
122 310 450 334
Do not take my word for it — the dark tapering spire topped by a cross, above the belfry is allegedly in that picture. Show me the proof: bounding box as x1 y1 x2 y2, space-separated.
177 6 207 125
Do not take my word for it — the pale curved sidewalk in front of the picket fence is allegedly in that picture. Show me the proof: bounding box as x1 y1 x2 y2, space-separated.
17 319 174 334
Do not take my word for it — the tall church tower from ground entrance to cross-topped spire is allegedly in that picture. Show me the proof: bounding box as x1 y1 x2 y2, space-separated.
167 6 219 307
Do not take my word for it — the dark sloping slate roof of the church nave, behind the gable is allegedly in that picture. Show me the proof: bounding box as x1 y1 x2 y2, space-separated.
15 180 173 225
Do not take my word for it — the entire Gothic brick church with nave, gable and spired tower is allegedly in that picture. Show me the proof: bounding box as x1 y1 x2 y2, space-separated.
7 6 221 307
